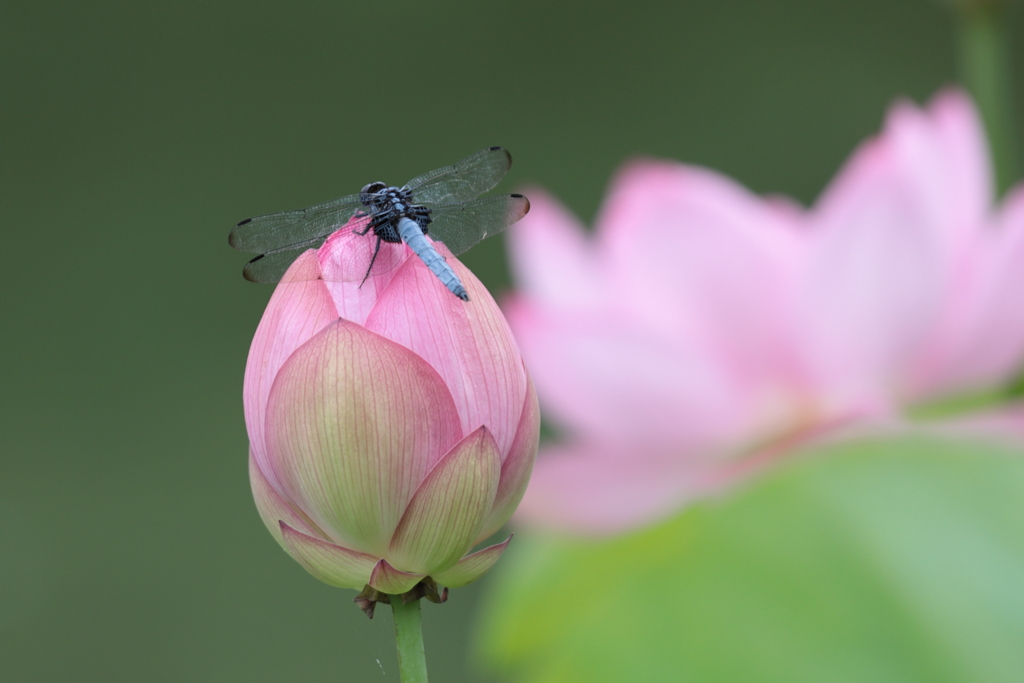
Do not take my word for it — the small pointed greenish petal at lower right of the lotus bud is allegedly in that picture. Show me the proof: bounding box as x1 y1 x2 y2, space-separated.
387 427 502 577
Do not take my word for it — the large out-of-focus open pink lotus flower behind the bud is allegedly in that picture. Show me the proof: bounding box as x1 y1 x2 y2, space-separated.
506 90 1024 532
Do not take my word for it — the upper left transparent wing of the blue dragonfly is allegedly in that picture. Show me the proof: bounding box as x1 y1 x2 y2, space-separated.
227 195 362 253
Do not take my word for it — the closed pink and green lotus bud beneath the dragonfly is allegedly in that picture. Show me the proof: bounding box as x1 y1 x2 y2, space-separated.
245 228 540 614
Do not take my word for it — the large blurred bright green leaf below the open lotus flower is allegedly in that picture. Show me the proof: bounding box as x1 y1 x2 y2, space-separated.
478 435 1024 683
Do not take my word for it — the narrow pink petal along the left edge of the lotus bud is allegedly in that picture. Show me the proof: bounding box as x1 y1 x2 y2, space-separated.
243 250 338 488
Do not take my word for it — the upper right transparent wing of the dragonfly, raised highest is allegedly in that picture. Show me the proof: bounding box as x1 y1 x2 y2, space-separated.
406 146 512 204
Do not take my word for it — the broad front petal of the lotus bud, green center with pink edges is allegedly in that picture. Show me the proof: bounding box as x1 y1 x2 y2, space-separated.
261 319 461 557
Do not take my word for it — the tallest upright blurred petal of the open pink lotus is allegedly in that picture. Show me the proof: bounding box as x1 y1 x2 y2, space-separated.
802 96 983 400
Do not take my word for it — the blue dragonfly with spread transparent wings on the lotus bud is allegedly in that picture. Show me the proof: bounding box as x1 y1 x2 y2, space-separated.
227 146 529 301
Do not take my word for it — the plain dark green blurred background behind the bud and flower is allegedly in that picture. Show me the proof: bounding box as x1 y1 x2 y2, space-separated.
0 0 1024 683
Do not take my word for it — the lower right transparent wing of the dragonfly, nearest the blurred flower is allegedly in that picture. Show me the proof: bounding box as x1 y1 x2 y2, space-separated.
428 195 529 255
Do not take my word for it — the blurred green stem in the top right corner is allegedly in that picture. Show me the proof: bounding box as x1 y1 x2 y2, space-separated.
957 0 1019 196
